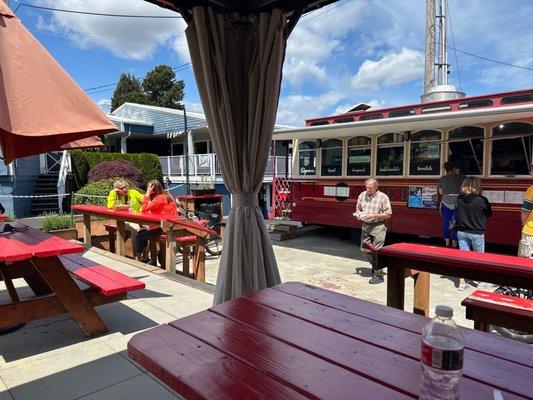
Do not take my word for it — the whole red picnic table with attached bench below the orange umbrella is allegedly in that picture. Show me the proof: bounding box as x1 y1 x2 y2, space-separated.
0 222 144 336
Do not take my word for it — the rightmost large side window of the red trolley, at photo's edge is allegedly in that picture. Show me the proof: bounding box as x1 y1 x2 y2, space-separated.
490 122 533 175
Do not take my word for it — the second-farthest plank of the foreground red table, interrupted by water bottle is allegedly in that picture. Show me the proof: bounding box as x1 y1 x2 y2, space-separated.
247 289 533 398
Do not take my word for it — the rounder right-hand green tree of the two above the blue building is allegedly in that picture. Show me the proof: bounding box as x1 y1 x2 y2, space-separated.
142 65 185 109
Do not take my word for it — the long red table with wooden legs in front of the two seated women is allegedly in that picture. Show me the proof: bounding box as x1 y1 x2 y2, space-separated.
72 204 217 281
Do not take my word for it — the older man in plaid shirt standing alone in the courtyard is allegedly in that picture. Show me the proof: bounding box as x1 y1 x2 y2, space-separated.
354 178 392 284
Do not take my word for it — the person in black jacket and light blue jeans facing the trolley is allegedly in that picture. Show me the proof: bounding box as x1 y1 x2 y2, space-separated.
457 177 492 290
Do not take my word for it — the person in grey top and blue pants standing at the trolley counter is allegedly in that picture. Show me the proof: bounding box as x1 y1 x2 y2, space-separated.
438 160 466 247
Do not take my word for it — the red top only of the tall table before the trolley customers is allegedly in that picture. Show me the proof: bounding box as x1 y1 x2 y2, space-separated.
378 243 533 277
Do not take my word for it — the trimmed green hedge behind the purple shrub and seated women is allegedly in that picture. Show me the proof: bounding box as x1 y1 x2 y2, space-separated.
71 150 163 188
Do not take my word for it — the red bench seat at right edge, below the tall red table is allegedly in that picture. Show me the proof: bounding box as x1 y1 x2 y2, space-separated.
461 290 533 333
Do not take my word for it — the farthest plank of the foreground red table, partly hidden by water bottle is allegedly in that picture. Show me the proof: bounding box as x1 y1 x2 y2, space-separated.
272 282 533 366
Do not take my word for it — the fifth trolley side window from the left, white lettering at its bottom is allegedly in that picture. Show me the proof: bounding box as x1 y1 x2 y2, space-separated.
409 130 442 175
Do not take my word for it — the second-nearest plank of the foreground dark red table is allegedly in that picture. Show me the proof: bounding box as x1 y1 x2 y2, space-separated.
170 311 411 400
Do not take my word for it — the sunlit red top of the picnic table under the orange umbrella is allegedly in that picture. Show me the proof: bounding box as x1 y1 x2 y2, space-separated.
0 222 85 263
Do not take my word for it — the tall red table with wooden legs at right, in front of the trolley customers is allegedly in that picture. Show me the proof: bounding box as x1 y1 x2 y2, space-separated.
378 243 533 315
